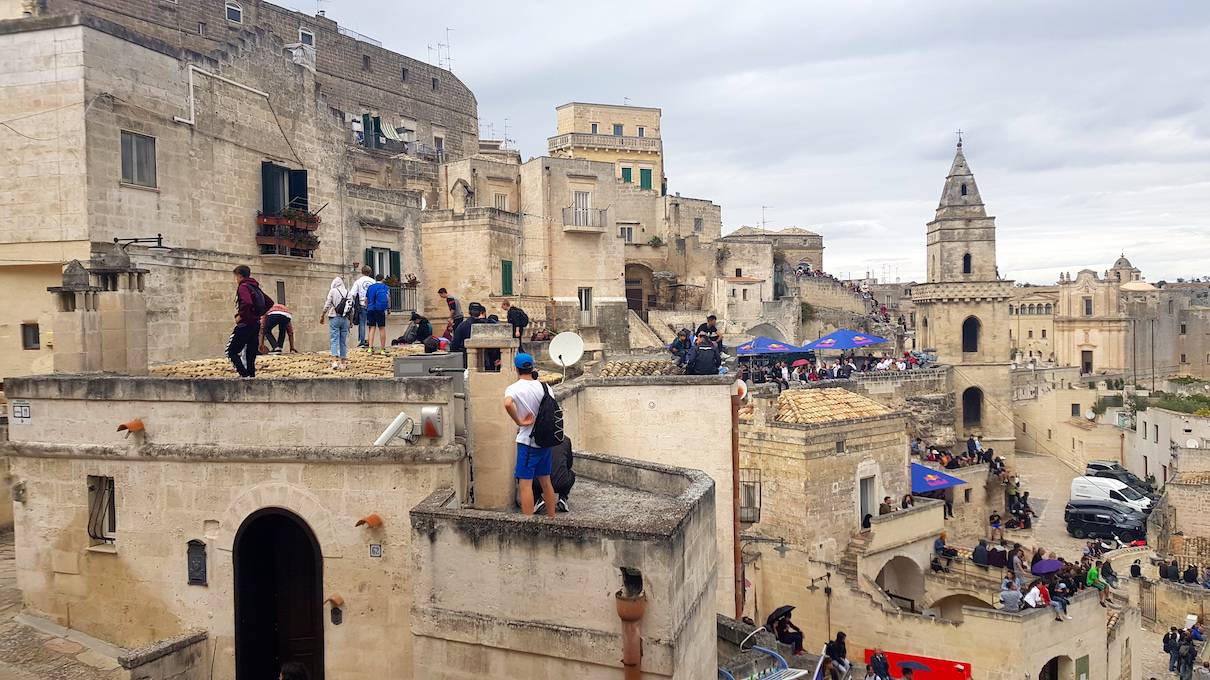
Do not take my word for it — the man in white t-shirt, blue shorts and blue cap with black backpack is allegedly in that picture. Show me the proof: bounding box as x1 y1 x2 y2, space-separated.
505 352 555 517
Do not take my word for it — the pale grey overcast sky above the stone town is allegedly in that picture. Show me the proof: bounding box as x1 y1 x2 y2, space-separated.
283 0 1210 283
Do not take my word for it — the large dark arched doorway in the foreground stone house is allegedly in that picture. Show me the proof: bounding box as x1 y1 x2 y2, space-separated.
231 508 323 680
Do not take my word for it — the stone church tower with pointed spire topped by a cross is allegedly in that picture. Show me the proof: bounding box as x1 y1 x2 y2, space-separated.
912 140 1015 452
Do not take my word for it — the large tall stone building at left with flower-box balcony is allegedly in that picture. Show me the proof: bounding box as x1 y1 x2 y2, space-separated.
0 0 479 375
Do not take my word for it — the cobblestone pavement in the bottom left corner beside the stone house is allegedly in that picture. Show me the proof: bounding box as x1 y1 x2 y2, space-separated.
0 532 121 680
